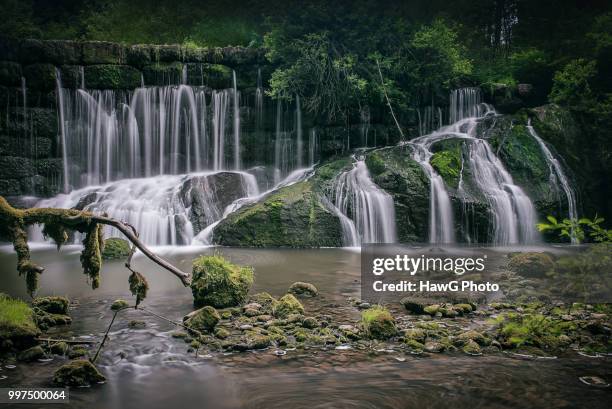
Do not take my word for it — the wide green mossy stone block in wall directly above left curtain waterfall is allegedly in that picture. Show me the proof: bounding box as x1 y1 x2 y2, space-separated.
85 65 141 90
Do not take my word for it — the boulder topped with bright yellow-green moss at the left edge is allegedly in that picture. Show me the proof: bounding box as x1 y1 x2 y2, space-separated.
0 294 40 351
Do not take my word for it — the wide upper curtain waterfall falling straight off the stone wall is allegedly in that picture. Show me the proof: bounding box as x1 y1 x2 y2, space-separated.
56 82 242 191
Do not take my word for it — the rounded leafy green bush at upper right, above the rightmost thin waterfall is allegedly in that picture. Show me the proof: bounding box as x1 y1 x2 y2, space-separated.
549 59 597 110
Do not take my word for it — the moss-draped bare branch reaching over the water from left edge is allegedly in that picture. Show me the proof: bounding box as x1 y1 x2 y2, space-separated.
0 196 189 294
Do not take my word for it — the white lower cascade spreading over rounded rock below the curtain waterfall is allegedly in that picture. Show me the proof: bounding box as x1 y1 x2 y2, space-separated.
34 172 259 245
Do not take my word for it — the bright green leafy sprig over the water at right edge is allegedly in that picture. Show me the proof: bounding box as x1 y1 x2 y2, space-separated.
537 216 612 243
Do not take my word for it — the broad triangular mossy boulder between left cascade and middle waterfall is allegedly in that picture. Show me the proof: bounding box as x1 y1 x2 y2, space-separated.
213 181 342 247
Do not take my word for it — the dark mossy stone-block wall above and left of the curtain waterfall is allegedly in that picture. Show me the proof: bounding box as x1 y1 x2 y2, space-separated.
0 39 271 196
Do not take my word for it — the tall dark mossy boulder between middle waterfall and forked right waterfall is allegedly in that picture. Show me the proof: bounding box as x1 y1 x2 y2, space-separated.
366 145 429 243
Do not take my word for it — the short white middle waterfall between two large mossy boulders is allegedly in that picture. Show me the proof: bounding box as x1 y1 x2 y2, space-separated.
333 159 397 246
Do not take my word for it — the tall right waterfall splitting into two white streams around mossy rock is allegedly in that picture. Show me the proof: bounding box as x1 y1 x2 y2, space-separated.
410 88 538 245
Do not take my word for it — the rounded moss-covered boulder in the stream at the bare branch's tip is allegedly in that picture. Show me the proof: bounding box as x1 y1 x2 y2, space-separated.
191 255 253 308
